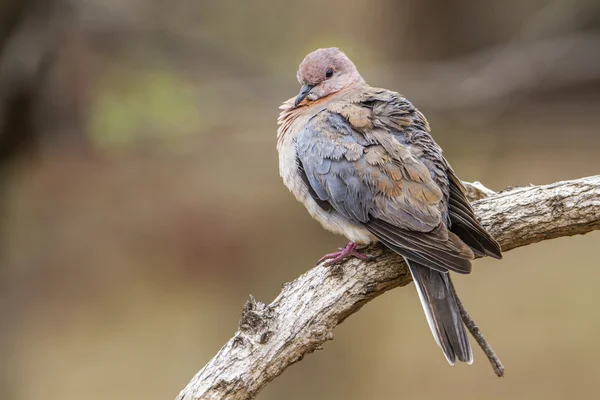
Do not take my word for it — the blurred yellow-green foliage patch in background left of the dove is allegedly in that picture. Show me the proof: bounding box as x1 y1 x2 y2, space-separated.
89 68 203 149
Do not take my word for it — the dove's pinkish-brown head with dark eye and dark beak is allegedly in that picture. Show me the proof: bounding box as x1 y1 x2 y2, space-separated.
295 47 364 107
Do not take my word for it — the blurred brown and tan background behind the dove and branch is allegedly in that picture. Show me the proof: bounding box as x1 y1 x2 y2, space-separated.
0 0 600 400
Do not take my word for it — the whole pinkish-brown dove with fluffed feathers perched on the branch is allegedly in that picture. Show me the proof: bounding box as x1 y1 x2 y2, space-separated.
277 47 502 365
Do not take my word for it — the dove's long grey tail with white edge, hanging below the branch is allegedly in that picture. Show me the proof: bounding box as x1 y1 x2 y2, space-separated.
406 260 473 365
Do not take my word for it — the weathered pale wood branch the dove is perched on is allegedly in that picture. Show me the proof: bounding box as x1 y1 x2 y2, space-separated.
177 175 600 400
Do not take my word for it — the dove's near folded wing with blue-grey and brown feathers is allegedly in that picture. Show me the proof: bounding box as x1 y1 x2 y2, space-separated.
296 95 473 273
